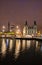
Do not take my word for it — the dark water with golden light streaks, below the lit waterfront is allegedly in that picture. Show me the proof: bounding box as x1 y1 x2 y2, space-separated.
0 39 42 65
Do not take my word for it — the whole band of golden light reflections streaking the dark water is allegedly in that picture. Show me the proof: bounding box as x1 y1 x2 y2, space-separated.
1 38 42 59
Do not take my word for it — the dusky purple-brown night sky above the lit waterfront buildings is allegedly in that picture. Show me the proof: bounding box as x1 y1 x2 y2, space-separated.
0 0 42 29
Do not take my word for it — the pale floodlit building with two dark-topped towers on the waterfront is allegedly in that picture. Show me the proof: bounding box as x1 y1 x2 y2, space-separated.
23 21 37 36
